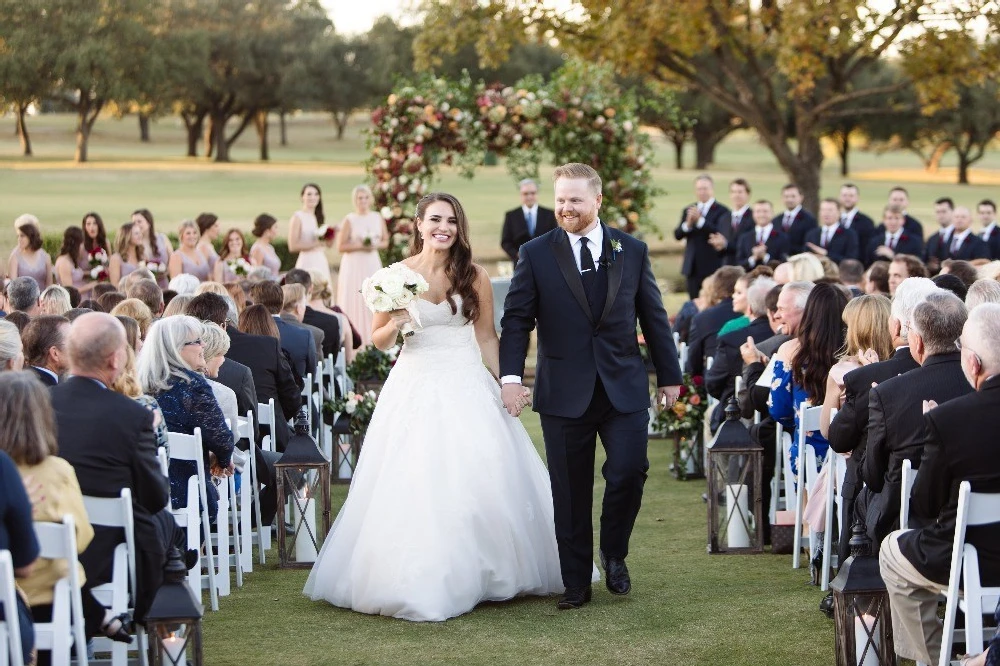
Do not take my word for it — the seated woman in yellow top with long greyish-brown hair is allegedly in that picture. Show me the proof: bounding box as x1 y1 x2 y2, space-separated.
0 372 131 643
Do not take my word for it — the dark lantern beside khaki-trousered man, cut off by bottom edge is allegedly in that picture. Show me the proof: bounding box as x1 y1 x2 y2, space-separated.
830 520 896 666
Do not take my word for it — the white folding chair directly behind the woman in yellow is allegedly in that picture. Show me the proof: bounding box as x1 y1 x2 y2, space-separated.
35 514 87 666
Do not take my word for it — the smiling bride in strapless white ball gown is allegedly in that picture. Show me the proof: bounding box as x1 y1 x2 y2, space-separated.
304 193 563 621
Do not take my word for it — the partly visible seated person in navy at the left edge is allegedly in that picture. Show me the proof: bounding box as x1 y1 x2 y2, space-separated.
0 450 39 664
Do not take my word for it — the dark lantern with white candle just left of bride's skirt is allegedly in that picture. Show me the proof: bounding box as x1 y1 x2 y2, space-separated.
274 410 330 567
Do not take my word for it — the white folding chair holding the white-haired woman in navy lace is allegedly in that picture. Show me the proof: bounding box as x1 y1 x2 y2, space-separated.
168 428 219 610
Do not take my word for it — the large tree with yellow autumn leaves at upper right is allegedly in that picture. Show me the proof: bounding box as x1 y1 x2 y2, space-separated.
415 0 1000 206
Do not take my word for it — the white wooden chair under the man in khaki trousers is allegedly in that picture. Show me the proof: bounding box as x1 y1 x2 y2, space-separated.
939 481 1000 666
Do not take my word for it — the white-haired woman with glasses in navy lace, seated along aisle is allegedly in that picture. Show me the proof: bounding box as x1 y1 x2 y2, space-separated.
139 315 234 520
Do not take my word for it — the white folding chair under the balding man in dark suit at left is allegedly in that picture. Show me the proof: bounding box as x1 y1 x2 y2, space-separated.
83 488 147 666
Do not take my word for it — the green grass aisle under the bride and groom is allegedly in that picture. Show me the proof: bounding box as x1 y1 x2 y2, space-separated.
204 412 833 666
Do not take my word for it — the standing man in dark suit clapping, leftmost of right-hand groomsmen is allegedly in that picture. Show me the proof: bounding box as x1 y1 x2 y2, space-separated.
674 174 729 300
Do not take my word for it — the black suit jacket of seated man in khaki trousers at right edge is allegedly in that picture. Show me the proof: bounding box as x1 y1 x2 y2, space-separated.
899 377 1000 586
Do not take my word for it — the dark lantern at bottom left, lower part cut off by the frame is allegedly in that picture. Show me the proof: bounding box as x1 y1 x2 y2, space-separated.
146 546 205 666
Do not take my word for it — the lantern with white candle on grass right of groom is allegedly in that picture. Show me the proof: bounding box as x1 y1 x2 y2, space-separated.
708 399 764 553
